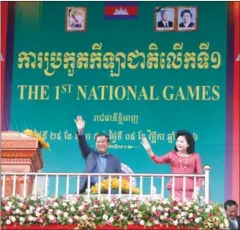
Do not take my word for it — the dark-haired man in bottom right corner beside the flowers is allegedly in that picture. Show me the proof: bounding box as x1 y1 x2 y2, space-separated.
224 200 240 230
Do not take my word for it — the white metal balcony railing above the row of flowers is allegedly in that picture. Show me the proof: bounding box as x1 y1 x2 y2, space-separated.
1 166 210 203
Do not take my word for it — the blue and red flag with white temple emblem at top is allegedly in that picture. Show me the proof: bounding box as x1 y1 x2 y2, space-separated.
104 2 138 19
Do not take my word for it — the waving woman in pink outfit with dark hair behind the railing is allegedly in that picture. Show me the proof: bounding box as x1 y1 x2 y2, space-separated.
142 130 203 201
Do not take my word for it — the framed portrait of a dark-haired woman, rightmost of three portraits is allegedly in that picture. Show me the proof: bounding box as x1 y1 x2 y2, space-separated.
177 6 198 31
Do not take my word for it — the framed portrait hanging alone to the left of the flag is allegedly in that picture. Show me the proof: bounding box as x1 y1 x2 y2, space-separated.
66 7 87 32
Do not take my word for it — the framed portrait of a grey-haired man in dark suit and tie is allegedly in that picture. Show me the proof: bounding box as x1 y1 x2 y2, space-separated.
154 6 176 32
